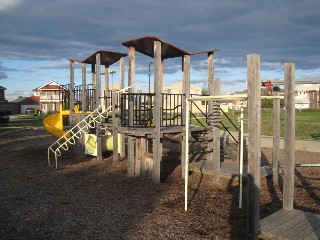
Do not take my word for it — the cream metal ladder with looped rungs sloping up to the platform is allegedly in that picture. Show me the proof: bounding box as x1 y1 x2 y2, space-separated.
48 106 112 168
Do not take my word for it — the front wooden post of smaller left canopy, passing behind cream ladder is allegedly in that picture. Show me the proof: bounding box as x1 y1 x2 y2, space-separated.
95 53 102 160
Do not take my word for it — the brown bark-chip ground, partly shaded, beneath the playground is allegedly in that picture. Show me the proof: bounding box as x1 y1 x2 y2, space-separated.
0 130 320 239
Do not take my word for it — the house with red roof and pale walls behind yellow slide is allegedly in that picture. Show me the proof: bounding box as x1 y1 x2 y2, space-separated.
32 81 62 113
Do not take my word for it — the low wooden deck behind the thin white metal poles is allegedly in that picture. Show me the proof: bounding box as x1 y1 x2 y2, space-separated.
189 160 272 179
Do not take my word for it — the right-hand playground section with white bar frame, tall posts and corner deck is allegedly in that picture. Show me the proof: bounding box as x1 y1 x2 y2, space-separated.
184 54 320 239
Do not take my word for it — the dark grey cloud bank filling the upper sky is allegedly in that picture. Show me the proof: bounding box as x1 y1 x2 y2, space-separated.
0 0 320 72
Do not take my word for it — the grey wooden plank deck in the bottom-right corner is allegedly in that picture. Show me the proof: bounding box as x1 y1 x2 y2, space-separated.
257 209 320 240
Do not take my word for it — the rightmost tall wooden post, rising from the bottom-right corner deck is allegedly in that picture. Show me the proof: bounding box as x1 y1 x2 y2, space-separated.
283 63 296 210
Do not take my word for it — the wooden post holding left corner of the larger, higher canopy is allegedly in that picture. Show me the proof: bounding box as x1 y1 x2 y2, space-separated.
128 47 136 177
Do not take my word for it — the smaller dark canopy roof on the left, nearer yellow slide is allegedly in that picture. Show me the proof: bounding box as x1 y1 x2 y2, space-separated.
82 50 127 67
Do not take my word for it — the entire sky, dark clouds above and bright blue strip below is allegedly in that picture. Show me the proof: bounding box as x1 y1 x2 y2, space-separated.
0 0 320 101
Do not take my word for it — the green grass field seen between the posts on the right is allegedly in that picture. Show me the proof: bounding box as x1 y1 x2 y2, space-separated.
192 108 320 140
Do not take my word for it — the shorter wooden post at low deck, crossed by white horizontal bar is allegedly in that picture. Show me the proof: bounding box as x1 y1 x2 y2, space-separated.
212 78 220 183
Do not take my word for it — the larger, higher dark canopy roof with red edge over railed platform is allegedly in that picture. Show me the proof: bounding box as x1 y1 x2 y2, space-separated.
122 36 190 59
